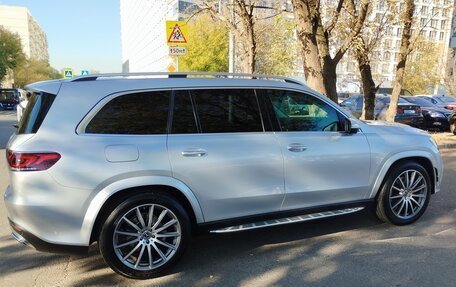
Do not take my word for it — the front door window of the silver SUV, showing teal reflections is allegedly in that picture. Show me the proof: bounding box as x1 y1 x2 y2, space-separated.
258 90 341 131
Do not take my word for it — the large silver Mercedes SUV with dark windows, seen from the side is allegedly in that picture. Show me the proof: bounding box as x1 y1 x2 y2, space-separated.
4 74 443 279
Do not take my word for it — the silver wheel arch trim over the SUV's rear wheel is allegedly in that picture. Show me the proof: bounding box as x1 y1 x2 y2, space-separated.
81 176 204 244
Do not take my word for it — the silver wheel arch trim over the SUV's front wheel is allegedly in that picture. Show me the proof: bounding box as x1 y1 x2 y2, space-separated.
369 151 438 200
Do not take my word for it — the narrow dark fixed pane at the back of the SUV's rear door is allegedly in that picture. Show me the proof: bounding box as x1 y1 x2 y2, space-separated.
172 91 198 134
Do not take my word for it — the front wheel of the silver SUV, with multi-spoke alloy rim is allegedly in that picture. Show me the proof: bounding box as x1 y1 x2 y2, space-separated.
376 161 432 225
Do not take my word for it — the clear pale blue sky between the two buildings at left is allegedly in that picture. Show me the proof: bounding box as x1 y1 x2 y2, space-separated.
0 0 122 75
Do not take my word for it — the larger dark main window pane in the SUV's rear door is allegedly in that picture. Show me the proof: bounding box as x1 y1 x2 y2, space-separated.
190 89 263 133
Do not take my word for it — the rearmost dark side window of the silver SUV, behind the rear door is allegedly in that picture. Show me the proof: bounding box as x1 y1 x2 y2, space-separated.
86 91 169 134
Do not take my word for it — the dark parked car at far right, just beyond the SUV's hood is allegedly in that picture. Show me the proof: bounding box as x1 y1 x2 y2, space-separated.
401 97 452 131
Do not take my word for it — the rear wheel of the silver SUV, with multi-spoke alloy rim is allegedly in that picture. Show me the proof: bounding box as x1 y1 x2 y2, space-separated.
98 192 191 279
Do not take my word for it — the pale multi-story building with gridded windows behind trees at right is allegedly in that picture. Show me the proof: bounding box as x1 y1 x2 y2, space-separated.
337 0 454 93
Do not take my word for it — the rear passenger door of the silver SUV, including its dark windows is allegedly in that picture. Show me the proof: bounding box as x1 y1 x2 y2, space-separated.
168 89 285 222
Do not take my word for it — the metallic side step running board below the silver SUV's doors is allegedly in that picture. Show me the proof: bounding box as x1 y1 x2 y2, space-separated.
210 207 364 233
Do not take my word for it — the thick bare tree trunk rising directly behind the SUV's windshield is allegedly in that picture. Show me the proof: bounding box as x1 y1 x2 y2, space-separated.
292 0 328 95
